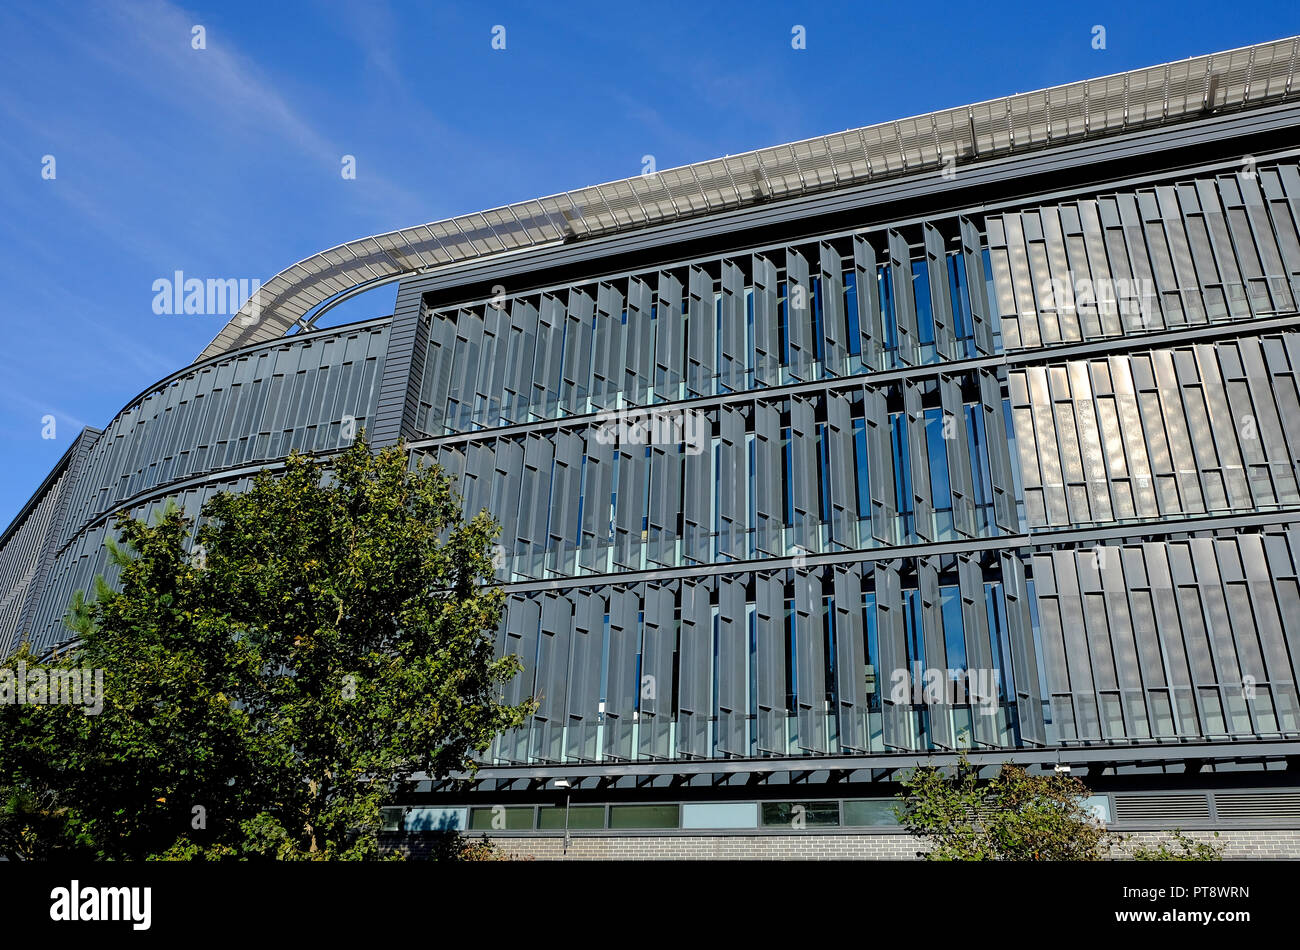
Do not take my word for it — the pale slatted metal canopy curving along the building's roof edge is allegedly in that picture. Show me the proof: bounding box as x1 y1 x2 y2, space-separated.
195 36 1300 361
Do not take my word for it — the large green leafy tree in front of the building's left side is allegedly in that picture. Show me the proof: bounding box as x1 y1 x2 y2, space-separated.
0 437 534 859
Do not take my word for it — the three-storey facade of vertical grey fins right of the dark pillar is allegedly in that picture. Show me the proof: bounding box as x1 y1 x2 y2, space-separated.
400 157 1300 764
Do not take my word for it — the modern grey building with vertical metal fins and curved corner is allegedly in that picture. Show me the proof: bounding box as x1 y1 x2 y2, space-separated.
0 38 1300 856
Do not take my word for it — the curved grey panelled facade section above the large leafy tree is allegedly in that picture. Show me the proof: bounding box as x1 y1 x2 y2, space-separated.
0 320 389 651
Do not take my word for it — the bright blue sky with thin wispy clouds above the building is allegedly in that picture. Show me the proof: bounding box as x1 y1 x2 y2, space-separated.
0 0 1300 528
